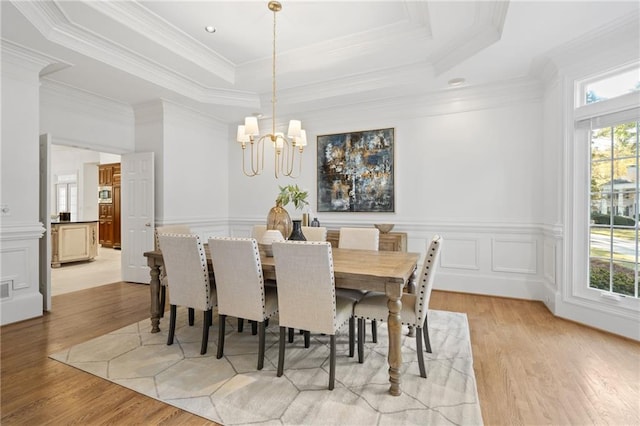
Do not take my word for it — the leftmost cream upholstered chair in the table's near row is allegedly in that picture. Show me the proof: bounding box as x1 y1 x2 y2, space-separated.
158 234 216 355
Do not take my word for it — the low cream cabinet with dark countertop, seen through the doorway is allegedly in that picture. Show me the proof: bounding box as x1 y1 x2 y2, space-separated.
51 221 98 268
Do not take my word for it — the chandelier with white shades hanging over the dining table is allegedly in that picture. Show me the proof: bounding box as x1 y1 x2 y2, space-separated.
236 1 307 179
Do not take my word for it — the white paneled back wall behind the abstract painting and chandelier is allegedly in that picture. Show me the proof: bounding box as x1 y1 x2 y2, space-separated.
229 81 544 300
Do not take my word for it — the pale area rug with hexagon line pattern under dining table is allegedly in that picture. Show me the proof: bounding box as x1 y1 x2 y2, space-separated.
50 308 482 425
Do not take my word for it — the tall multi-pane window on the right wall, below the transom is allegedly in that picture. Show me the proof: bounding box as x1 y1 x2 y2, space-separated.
589 121 640 298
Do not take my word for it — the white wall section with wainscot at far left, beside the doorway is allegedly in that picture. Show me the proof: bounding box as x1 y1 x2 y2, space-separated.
0 43 47 324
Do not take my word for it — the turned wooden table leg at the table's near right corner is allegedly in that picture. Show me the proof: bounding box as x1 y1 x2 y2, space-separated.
385 283 402 396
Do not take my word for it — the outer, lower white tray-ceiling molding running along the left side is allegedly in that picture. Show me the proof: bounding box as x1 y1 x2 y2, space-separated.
13 1 259 108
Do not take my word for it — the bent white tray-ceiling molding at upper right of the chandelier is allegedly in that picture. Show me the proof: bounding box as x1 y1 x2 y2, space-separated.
430 0 509 75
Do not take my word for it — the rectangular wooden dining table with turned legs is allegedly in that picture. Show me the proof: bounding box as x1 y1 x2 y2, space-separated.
144 245 419 396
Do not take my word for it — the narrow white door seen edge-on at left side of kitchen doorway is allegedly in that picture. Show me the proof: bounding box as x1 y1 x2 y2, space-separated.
38 133 51 311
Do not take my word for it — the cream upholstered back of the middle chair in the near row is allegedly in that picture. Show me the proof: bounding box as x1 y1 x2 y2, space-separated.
209 237 265 321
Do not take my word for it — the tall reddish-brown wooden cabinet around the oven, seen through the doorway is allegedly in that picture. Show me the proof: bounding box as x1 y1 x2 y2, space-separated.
98 163 121 249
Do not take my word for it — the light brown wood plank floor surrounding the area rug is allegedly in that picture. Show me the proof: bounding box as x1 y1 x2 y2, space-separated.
0 283 640 425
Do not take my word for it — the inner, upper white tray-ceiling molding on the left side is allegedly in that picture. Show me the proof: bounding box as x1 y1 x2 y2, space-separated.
85 1 236 84
